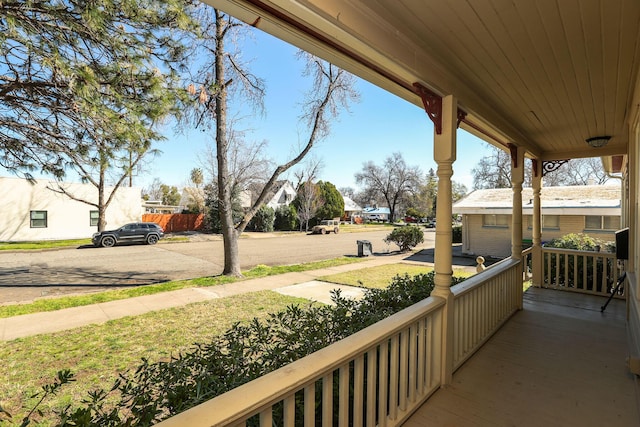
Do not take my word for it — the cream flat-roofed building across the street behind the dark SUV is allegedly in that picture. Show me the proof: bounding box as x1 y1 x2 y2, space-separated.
0 177 142 242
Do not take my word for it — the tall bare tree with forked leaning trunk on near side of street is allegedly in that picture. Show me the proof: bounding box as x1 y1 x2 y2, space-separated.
182 9 357 276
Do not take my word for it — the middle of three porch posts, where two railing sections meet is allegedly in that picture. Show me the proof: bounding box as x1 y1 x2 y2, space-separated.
509 144 524 310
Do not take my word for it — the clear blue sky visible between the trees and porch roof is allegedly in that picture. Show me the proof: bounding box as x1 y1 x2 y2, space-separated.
142 30 488 190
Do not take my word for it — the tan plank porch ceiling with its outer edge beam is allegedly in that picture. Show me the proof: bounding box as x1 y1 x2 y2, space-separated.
204 0 640 160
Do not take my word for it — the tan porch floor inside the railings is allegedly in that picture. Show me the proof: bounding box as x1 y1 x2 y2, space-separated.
404 288 640 427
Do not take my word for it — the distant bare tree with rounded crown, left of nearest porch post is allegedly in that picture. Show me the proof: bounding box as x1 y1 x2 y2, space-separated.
355 153 422 222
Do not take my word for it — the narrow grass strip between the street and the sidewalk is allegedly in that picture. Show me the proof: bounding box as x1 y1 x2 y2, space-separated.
0 257 366 318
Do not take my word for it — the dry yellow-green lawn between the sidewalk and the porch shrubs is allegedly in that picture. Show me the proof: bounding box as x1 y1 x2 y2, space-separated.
0 291 308 425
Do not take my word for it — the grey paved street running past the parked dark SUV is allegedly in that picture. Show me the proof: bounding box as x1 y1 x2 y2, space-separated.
0 230 435 304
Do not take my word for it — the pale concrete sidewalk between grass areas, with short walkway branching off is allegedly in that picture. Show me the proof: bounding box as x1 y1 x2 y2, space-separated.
0 254 440 341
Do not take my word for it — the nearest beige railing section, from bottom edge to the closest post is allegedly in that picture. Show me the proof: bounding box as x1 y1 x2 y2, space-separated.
159 298 444 427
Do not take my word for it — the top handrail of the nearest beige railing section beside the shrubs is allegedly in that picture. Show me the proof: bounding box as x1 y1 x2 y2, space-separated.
157 297 445 427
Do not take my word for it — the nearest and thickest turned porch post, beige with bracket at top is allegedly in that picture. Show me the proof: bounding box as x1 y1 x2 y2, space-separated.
432 95 457 385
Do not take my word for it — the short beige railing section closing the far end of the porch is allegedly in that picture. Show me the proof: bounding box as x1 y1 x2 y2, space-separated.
541 246 624 298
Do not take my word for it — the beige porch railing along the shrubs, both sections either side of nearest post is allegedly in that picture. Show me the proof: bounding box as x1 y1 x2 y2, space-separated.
158 259 522 427
